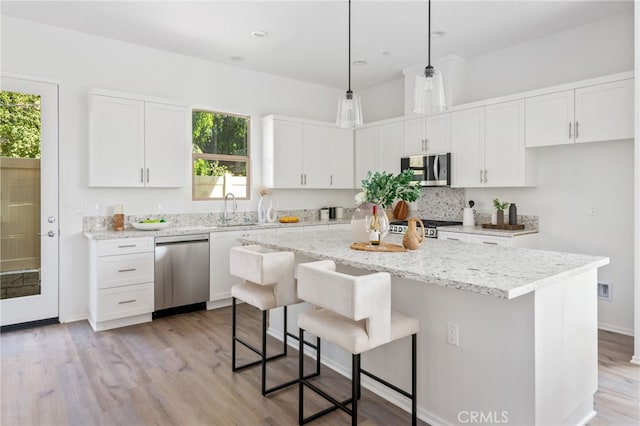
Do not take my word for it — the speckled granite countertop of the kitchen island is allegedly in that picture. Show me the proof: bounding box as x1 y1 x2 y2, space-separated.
240 230 609 299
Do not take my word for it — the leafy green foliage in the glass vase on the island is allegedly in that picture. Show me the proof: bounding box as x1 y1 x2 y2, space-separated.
356 169 421 208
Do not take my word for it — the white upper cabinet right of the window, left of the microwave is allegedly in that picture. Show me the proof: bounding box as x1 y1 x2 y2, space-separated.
262 115 353 189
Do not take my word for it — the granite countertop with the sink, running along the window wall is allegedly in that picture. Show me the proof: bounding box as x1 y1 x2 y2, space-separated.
84 219 351 240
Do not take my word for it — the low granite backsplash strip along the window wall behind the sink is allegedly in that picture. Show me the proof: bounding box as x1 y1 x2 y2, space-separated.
82 208 354 232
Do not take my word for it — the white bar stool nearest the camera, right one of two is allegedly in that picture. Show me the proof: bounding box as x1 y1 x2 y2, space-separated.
298 260 419 425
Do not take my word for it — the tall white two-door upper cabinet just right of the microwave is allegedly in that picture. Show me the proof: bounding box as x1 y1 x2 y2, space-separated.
451 100 536 188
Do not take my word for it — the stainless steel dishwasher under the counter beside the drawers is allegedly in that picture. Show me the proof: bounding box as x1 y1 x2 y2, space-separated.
154 234 209 316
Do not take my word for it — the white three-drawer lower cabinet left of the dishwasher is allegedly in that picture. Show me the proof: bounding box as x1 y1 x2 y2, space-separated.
89 237 154 331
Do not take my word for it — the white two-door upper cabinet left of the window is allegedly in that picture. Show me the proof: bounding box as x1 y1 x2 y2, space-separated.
89 94 189 188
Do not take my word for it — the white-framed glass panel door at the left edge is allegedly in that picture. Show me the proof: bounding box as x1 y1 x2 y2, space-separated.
0 77 58 326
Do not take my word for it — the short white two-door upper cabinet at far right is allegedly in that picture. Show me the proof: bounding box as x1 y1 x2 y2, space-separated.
526 79 634 147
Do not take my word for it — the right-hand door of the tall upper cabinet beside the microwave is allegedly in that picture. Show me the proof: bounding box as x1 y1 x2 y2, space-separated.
484 100 525 186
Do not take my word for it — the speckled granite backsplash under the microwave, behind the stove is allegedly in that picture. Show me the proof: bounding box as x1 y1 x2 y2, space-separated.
409 188 464 222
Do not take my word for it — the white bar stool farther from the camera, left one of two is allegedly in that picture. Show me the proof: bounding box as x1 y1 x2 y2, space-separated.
229 245 320 395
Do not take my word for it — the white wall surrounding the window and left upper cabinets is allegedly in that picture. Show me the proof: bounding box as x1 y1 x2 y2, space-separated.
1 16 355 321
